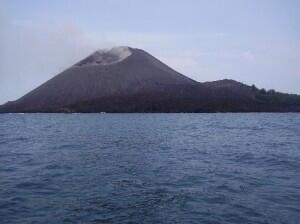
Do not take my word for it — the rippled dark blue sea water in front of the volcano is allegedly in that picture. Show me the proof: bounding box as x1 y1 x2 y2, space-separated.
0 113 300 224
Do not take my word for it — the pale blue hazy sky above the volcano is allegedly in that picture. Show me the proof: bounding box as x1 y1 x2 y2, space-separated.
0 0 300 104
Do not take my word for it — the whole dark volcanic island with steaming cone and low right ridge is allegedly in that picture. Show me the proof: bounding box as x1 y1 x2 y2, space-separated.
0 47 300 113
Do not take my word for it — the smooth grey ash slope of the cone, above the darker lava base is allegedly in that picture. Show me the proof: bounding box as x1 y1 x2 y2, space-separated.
4 48 197 110
